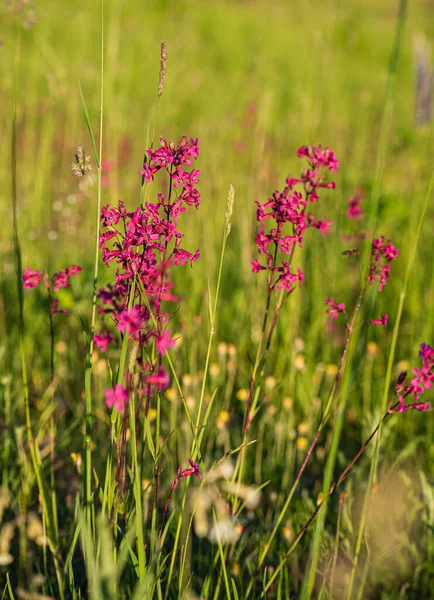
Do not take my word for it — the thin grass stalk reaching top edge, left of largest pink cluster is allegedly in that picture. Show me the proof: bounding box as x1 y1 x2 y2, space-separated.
80 0 104 531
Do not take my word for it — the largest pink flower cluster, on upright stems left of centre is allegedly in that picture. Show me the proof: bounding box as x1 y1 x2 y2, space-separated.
99 136 200 408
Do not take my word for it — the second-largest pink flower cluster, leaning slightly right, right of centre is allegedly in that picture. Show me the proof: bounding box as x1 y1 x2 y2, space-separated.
251 146 339 292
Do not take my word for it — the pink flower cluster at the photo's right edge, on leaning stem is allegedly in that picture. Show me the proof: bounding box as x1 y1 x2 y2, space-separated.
389 344 434 412
